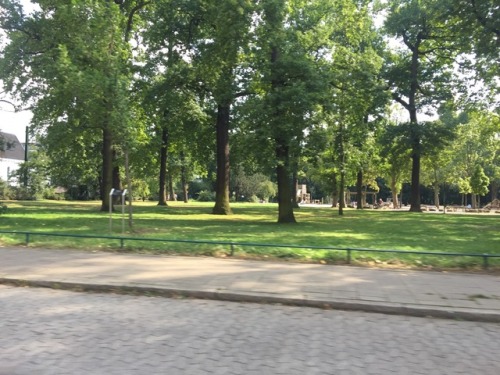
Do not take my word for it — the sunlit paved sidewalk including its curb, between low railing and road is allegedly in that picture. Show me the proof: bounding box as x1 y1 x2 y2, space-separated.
0 247 500 322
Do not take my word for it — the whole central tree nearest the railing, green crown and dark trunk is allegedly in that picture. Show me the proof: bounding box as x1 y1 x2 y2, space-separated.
256 0 360 223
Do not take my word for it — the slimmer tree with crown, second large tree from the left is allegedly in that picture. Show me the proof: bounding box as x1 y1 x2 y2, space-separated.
136 0 204 206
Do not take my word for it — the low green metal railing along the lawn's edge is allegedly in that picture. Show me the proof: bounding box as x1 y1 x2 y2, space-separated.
0 230 500 269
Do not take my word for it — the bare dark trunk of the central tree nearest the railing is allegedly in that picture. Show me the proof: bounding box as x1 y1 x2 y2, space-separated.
276 137 297 223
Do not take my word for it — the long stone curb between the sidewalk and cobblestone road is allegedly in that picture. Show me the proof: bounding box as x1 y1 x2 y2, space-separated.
0 278 500 323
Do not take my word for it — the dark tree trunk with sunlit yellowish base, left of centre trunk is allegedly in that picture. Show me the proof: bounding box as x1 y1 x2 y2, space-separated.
212 103 232 215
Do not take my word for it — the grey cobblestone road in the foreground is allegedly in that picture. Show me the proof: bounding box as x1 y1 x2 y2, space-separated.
0 286 500 375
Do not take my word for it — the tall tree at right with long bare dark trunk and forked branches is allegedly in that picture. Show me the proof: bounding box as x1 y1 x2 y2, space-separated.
385 0 454 212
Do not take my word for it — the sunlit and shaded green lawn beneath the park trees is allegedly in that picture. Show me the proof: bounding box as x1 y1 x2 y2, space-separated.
0 201 500 269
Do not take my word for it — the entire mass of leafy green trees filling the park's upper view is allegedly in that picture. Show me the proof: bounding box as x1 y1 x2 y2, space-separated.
0 0 500 219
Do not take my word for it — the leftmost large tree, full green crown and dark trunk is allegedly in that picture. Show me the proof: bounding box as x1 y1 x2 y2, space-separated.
0 0 138 211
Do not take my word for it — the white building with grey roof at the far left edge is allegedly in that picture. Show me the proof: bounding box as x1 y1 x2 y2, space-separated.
0 132 24 184
